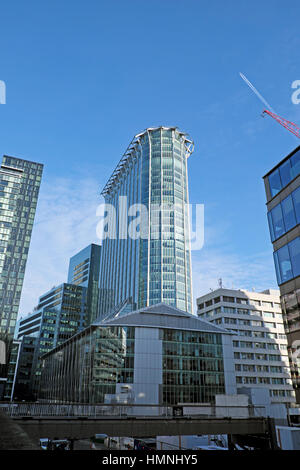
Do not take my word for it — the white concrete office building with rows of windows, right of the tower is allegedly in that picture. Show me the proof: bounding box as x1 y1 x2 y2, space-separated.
197 288 295 404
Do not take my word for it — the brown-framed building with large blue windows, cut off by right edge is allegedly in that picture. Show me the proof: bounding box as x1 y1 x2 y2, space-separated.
264 146 300 403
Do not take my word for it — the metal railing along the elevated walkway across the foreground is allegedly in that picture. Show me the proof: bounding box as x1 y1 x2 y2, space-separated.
0 403 267 419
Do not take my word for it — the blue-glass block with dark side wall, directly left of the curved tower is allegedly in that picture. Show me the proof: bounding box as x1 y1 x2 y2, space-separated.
67 243 101 326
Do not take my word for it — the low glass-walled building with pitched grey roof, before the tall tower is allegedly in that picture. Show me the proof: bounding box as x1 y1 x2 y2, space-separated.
39 304 236 405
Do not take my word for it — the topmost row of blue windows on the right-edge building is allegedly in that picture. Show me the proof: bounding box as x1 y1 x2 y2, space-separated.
268 150 300 197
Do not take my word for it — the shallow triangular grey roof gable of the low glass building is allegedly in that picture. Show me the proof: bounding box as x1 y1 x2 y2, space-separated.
93 303 231 334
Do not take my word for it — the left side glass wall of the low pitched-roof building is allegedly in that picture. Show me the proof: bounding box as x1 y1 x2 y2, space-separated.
40 326 135 403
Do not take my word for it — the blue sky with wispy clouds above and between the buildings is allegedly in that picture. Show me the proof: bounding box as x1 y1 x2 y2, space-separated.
0 0 300 314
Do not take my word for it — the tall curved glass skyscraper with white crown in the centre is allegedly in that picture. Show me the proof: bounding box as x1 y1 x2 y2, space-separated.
99 127 193 317
